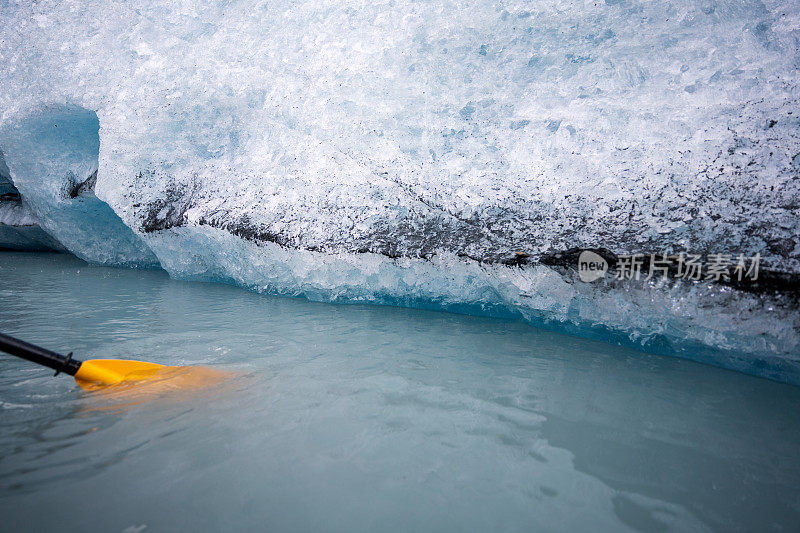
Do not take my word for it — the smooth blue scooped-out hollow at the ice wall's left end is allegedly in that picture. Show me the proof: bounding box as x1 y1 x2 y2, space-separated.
0 106 158 267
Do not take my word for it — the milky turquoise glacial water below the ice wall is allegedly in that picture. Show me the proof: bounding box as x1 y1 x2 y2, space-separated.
0 252 800 532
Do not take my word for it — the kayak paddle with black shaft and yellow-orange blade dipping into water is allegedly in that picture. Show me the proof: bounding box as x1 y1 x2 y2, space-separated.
0 333 191 389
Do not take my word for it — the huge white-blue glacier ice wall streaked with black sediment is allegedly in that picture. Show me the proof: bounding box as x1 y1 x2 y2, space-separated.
0 0 800 383
